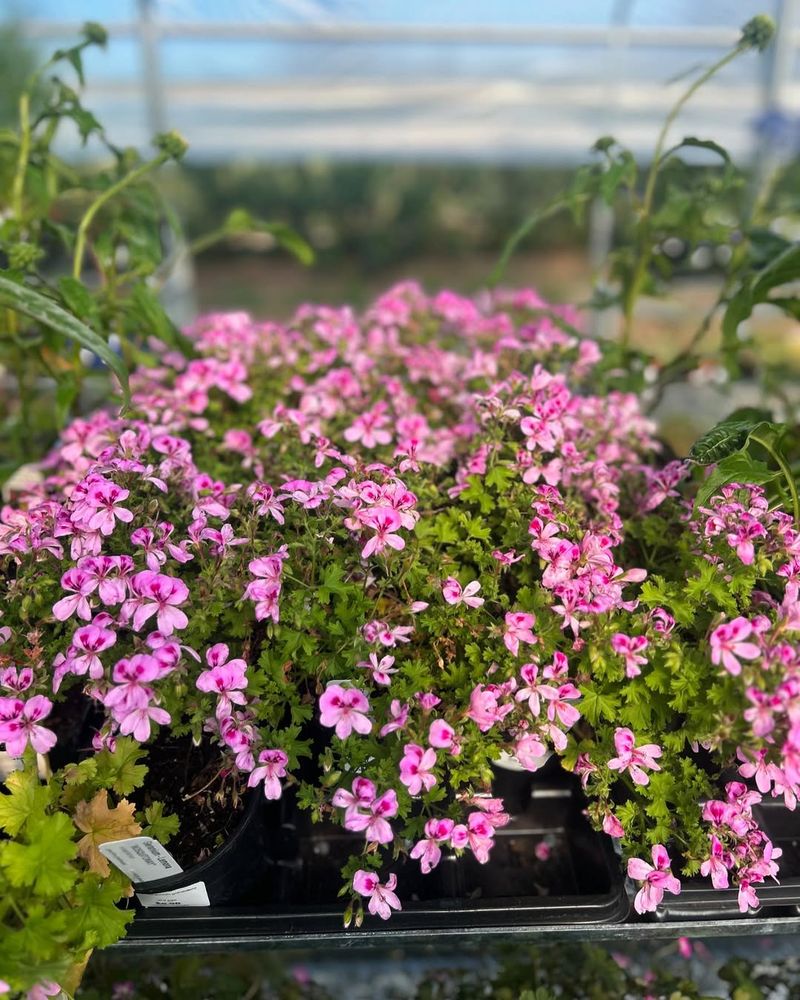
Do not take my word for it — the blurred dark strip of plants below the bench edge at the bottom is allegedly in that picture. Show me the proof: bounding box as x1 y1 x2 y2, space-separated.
78 938 800 1000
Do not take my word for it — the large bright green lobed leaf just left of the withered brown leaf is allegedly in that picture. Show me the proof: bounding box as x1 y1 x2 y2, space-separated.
0 813 78 897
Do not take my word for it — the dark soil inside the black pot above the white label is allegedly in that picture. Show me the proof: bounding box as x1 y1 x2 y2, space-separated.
141 736 246 869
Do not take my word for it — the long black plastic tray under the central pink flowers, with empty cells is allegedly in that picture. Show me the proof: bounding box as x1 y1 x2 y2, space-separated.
128 774 629 947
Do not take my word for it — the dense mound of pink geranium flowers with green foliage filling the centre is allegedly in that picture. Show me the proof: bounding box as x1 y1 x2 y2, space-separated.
0 284 800 936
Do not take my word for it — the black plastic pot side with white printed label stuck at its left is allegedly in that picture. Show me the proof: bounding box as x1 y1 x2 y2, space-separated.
133 792 271 919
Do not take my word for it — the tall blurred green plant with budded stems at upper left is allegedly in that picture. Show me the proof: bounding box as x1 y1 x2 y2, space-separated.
0 23 313 482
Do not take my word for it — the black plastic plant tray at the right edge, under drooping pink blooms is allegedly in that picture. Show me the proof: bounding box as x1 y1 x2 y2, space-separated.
655 799 800 921
